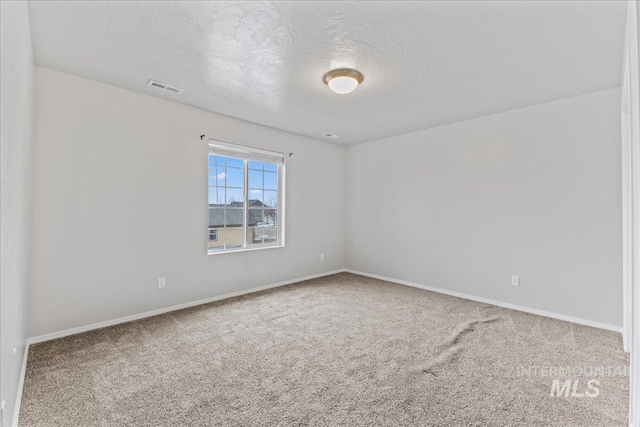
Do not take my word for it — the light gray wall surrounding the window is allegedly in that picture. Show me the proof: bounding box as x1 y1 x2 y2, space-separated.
29 67 345 336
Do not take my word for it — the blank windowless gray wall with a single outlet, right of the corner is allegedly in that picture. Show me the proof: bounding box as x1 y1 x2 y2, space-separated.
347 89 622 326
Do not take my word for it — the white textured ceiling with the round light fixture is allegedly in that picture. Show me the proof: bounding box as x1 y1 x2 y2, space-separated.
30 1 627 145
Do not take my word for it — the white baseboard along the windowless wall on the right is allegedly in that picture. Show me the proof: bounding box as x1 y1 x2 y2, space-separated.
345 268 622 333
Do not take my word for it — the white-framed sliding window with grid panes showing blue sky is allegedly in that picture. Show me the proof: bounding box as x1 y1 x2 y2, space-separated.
207 141 284 253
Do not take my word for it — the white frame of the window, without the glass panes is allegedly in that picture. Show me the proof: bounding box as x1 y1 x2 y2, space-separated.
206 139 285 255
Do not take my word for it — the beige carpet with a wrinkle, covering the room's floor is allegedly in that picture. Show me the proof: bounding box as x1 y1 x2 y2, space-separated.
20 273 628 427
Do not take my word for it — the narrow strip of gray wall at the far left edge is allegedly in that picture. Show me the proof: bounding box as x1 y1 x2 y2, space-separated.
0 1 34 425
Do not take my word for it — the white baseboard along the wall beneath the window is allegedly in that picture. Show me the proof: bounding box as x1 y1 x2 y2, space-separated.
27 269 345 344
